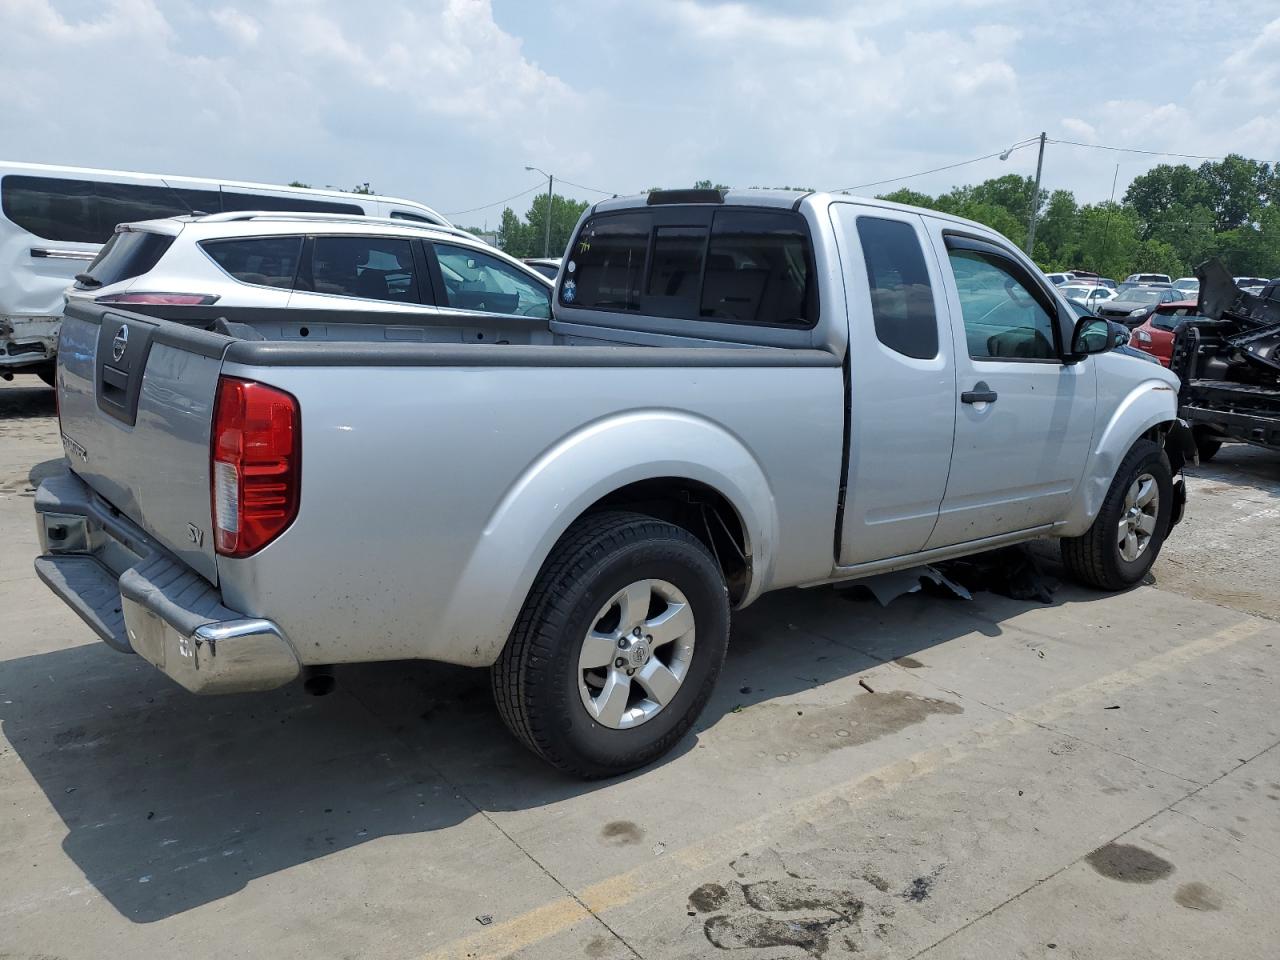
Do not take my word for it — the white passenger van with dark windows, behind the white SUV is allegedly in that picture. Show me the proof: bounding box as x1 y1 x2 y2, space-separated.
0 161 452 383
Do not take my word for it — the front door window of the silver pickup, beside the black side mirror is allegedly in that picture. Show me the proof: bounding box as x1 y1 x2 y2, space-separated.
948 248 1057 360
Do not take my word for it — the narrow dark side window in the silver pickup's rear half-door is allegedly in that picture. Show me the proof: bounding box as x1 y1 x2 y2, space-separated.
858 216 938 360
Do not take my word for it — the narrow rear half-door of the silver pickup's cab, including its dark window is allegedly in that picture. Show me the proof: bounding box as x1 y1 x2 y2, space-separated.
831 204 956 566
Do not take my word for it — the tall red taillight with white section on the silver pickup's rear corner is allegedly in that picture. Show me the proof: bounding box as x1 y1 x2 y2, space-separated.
210 376 302 557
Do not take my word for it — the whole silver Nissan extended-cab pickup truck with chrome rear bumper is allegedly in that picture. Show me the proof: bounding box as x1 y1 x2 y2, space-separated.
36 191 1193 777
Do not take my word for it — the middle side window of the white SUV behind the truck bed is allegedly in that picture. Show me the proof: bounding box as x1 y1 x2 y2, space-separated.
311 237 420 303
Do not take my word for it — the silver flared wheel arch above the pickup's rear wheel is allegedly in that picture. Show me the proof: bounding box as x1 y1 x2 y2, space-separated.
433 410 778 666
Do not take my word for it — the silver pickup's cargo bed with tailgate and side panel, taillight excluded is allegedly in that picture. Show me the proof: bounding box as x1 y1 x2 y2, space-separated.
47 303 845 666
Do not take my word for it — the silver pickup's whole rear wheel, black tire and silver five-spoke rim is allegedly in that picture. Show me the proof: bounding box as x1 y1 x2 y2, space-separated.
493 512 730 778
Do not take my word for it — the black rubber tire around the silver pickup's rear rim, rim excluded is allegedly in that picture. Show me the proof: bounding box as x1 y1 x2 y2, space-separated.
492 512 730 780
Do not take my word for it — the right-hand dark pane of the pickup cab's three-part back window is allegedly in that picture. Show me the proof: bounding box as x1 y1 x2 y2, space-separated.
698 210 817 326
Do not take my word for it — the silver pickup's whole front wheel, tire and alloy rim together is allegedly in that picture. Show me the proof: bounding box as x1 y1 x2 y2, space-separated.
1062 440 1174 590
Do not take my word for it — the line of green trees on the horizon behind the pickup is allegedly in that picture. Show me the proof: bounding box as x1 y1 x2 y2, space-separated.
483 155 1280 279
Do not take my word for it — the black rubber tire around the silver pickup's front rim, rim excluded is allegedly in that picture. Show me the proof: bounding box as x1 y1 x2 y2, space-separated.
1062 440 1174 590
